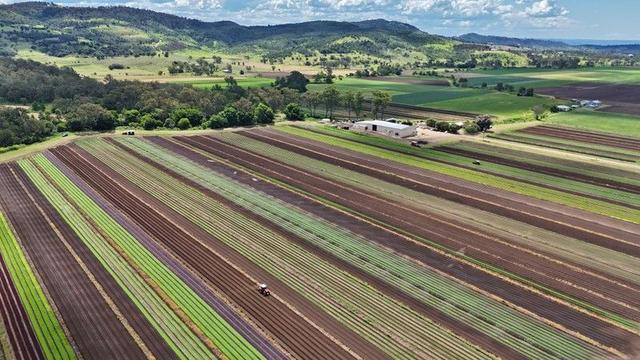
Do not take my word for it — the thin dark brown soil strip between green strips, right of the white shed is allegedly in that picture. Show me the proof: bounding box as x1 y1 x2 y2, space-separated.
436 146 640 195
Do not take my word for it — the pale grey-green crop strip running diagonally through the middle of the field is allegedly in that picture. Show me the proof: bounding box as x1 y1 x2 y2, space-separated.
111 136 608 358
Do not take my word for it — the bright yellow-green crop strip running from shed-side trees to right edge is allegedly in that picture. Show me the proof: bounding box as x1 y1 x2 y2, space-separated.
278 126 640 224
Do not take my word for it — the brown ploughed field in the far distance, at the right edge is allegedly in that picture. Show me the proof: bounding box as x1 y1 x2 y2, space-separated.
536 83 640 115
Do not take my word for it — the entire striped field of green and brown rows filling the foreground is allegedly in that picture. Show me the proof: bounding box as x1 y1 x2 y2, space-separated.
0 126 640 360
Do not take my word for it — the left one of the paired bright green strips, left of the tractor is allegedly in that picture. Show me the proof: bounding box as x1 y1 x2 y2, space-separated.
19 155 222 359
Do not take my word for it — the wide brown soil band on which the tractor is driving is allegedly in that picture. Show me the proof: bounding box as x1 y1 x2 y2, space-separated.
51 147 385 359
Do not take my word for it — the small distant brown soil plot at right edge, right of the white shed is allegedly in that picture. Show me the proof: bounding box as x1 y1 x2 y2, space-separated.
520 126 640 151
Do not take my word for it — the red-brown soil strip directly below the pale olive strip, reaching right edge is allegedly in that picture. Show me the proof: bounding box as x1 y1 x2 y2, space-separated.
226 131 640 319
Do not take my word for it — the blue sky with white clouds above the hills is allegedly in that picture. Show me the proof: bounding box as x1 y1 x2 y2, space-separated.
5 0 640 40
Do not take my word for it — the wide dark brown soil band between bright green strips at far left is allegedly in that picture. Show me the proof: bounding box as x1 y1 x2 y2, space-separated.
0 164 176 359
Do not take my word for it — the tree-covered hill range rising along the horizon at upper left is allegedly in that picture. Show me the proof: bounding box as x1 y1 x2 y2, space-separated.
0 2 450 56
